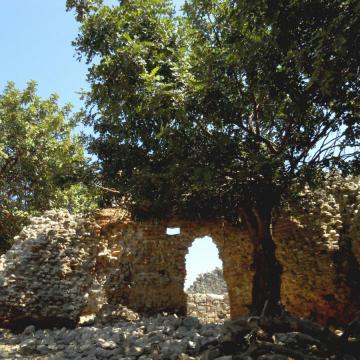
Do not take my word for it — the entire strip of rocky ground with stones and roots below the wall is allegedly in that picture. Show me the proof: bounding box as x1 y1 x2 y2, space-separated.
0 314 360 360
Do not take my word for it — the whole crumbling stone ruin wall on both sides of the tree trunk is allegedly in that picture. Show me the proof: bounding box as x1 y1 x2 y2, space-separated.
0 175 360 327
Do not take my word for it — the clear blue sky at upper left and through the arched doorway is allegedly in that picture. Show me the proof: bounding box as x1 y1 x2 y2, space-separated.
0 0 221 287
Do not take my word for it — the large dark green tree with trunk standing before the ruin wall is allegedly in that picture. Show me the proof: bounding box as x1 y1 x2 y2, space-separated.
68 0 360 313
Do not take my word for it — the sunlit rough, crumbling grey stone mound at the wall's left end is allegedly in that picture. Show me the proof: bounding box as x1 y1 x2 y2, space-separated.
0 210 99 327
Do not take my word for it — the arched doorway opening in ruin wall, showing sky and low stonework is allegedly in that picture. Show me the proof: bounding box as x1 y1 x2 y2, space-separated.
184 236 230 323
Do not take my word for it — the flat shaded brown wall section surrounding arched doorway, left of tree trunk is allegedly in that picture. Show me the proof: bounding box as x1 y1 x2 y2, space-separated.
97 214 253 318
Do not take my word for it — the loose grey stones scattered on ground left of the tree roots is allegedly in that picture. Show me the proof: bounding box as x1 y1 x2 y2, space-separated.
0 314 220 360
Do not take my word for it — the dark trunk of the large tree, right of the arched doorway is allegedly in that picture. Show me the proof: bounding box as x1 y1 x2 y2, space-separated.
242 207 282 315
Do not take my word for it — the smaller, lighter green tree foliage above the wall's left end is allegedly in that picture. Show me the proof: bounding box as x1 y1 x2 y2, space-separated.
0 82 96 247
